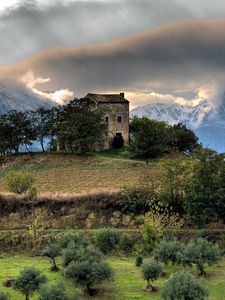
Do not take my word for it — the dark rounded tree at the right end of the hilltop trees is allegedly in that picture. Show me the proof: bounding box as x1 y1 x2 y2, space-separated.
168 123 199 153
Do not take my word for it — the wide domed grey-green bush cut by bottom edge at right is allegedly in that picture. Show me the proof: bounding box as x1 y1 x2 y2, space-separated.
162 271 208 300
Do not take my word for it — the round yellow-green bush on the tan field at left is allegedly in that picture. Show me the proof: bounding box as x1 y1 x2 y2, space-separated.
5 171 35 194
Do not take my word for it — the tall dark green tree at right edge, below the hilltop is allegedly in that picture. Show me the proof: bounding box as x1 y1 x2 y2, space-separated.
185 149 225 227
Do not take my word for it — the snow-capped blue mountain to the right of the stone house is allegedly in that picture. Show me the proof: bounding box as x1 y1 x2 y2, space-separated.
131 100 225 152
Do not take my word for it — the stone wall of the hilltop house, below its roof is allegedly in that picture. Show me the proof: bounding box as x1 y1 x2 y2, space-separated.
98 102 129 148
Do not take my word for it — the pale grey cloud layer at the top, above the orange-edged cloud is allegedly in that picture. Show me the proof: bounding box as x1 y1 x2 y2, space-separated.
0 0 225 64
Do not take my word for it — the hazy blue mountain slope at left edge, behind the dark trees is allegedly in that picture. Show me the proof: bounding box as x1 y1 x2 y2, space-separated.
0 84 54 114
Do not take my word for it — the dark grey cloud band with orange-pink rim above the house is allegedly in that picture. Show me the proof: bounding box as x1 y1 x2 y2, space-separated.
1 19 225 105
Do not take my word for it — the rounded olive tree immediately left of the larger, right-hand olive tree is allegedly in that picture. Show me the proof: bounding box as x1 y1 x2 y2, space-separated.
154 239 183 265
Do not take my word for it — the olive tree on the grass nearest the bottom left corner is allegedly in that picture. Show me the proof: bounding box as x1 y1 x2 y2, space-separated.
13 267 47 300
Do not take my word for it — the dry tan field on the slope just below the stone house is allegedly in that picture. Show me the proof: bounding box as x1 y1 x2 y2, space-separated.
0 152 162 193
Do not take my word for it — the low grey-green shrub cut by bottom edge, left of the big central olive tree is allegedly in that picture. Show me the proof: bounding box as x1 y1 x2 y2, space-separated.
39 281 79 300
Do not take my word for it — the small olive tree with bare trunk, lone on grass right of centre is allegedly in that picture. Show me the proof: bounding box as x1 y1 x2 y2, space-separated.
141 259 162 291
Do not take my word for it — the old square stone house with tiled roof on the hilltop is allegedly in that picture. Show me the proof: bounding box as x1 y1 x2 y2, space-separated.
85 93 129 151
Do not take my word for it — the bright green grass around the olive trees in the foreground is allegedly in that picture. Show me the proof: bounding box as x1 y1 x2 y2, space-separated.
0 254 225 300
